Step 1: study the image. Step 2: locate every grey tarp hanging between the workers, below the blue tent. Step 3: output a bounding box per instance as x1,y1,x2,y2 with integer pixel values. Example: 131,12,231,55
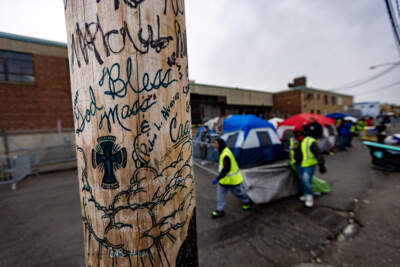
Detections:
241,162,299,204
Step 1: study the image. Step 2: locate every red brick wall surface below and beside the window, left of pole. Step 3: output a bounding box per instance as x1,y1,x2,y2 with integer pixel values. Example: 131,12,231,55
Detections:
0,55,74,131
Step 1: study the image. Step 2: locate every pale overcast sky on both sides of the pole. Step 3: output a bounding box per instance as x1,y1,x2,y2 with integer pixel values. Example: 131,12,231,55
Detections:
0,0,400,104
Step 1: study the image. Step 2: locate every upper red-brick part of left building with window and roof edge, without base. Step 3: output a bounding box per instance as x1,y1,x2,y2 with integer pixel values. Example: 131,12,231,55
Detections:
0,33,73,131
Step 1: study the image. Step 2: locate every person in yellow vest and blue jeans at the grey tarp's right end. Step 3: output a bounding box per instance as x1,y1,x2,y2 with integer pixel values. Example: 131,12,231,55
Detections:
294,129,326,208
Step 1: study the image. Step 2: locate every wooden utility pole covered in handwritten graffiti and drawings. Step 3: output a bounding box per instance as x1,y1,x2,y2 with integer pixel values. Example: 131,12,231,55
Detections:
64,0,197,267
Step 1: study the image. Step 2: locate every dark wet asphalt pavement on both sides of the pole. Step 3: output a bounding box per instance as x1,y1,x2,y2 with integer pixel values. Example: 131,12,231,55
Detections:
0,137,400,267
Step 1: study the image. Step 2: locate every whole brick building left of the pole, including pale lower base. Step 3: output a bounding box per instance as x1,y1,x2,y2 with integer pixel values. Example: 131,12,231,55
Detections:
0,32,76,164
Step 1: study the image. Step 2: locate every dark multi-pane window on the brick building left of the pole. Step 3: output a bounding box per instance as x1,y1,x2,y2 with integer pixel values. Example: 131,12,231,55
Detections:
0,50,35,83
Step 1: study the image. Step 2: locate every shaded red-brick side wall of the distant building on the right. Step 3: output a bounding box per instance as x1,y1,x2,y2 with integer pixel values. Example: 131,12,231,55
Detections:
271,90,301,117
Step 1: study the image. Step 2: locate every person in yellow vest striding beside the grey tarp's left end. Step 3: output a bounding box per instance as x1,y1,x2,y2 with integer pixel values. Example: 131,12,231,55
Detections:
211,138,250,218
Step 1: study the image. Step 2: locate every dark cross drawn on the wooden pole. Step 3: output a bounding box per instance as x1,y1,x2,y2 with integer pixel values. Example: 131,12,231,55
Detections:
92,135,126,189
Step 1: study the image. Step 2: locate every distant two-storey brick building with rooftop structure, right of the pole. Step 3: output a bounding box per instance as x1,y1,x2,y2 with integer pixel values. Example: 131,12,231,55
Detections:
271,77,353,117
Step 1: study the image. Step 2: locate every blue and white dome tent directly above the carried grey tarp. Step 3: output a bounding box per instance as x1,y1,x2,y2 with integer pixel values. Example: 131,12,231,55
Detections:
221,115,287,167
